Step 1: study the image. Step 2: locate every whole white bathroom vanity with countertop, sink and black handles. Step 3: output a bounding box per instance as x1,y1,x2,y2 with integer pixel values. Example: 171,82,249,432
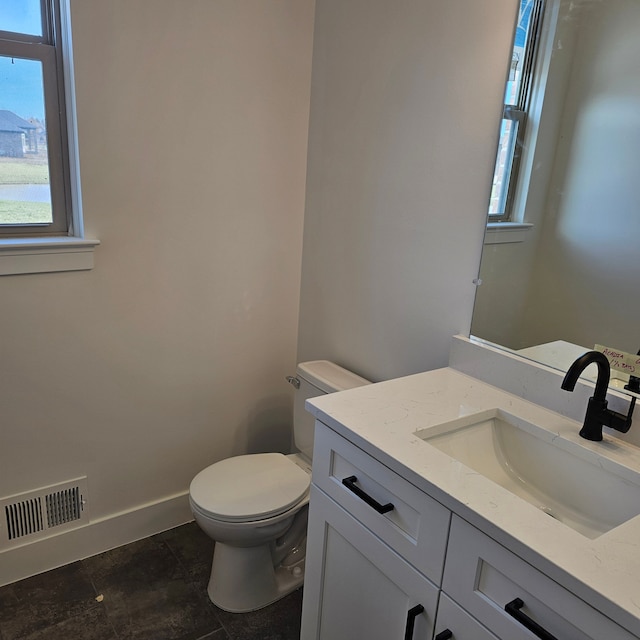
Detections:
301,338,640,640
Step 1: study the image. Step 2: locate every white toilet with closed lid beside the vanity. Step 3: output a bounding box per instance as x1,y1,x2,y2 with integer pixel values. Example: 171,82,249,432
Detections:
189,360,369,613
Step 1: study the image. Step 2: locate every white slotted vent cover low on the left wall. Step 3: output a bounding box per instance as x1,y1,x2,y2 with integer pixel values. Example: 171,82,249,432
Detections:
0,477,89,551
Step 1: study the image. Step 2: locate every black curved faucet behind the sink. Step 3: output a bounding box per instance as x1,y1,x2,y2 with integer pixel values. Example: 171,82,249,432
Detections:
562,351,636,441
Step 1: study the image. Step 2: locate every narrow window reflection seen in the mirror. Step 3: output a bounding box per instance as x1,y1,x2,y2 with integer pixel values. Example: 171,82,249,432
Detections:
489,0,544,222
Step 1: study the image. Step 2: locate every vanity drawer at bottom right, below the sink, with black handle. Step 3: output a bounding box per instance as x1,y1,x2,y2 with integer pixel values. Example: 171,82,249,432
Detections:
442,516,637,640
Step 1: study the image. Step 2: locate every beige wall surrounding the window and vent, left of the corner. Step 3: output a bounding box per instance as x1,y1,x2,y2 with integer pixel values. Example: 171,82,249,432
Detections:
0,0,314,581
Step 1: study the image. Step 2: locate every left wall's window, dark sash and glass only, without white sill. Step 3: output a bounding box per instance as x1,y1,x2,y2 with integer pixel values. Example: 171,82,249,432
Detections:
0,0,73,237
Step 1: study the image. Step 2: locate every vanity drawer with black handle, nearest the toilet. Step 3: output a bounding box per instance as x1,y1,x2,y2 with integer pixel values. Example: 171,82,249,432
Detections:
313,422,451,585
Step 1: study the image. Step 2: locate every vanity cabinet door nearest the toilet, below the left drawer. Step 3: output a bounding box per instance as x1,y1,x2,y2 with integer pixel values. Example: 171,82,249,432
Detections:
301,485,438,640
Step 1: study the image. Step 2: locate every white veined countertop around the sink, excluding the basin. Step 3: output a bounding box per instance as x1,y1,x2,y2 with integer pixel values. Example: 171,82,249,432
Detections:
307,368,640,637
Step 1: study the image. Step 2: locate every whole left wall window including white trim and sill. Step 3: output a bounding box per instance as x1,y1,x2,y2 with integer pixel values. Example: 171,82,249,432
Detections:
0,0,99,276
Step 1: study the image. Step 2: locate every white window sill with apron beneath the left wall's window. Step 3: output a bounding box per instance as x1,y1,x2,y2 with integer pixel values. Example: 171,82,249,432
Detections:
0,236,100,276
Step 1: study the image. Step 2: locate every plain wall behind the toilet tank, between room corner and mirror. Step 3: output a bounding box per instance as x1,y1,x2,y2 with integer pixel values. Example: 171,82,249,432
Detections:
298,0,518,380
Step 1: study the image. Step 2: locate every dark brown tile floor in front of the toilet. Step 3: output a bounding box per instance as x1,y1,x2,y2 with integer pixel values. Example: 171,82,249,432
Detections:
0,522,302,640
